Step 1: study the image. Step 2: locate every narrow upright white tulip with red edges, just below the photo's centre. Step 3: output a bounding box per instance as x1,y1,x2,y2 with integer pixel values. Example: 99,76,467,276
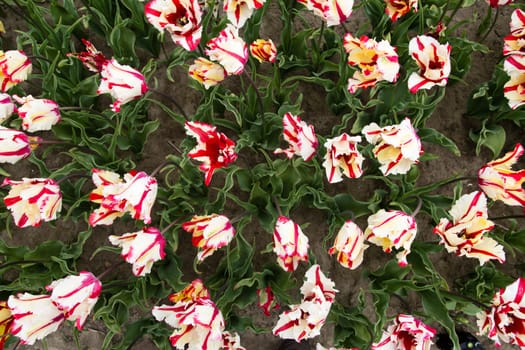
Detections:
273,215,308,272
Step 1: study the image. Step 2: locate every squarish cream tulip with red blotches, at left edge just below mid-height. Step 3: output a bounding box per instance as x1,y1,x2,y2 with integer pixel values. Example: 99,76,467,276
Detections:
2,178,62,227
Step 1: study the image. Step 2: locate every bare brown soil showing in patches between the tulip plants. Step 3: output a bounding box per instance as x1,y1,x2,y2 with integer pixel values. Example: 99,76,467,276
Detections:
2,0,525,350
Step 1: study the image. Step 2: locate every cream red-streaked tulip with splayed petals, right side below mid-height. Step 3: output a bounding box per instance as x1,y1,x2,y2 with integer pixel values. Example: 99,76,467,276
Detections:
434,191,505,265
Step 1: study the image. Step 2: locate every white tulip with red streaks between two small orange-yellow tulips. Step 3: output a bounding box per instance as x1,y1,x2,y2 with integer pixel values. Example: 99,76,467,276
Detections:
205,25,248,75
